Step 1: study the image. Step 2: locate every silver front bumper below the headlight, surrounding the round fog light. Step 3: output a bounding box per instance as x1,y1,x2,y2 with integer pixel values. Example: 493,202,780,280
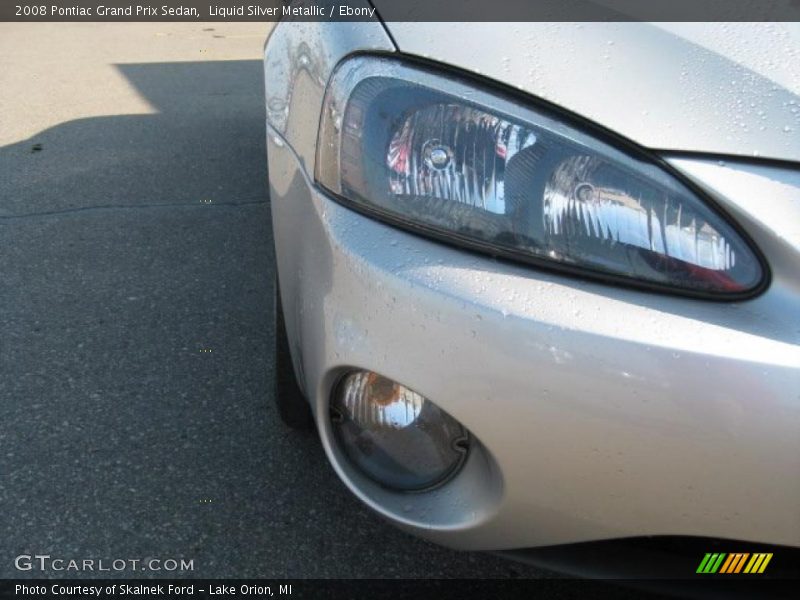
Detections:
268,126,800,550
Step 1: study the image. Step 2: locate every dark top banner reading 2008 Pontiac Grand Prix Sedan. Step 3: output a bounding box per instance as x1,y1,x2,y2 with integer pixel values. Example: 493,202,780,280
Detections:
0,0,800,22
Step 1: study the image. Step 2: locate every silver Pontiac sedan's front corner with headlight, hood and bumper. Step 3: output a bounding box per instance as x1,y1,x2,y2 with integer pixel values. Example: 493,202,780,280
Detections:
264,11,800,572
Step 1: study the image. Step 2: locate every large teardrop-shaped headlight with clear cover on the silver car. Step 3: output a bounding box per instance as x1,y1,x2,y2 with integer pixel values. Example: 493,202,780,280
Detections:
317,57,764,297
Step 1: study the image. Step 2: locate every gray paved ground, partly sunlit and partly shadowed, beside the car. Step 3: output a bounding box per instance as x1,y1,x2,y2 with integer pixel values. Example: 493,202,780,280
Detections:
0,24,556,577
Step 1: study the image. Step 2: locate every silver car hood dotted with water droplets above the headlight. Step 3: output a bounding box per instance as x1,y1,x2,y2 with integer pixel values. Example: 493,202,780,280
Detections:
386,22,800,161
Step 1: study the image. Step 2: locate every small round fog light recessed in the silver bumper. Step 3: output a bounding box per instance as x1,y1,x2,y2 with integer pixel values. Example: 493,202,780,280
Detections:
331,371,469,491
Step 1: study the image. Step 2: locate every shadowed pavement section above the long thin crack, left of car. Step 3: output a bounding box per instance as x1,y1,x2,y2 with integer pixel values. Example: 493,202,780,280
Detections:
0,61,267,215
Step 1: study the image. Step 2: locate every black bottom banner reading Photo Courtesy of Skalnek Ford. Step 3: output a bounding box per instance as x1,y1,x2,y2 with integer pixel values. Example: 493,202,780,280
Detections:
0,576,797,600
